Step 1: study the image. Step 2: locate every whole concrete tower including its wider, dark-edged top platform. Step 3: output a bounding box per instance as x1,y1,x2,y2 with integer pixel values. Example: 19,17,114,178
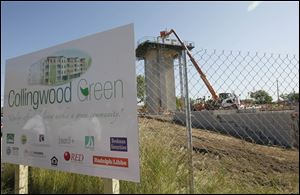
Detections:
136,38,194,114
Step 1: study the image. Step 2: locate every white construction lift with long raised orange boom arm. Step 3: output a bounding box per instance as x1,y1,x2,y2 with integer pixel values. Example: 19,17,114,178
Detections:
160,29,240,111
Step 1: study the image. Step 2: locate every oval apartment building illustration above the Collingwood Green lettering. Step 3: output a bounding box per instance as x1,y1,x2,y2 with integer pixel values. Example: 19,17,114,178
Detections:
28,51,91,85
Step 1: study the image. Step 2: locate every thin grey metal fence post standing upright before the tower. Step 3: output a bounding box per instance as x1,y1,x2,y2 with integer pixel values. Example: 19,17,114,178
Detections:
183,50,194,194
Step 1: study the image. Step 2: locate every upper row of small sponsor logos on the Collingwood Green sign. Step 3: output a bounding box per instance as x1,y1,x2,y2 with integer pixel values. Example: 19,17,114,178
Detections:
6,133,128,152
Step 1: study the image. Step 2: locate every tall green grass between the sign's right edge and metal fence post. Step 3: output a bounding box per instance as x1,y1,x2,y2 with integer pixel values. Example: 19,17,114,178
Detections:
120,129,187,194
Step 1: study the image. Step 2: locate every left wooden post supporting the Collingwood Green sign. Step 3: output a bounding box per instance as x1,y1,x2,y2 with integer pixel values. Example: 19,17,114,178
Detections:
15,165,28,194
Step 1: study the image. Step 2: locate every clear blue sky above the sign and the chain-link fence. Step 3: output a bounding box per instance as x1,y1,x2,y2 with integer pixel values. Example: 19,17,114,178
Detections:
1,1,299,105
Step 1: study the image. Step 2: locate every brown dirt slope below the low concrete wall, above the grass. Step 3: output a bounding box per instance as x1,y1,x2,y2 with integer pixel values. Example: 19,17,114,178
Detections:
139,118,299,187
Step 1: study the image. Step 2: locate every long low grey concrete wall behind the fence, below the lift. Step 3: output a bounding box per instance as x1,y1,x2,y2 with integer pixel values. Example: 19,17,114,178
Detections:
174,110,299,148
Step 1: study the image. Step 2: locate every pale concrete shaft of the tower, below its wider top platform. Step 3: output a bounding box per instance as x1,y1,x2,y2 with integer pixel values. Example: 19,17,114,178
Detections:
144,48,177,114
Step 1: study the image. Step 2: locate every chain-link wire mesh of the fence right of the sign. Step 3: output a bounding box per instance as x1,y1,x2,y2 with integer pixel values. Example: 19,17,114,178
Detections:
136,45,299,193
